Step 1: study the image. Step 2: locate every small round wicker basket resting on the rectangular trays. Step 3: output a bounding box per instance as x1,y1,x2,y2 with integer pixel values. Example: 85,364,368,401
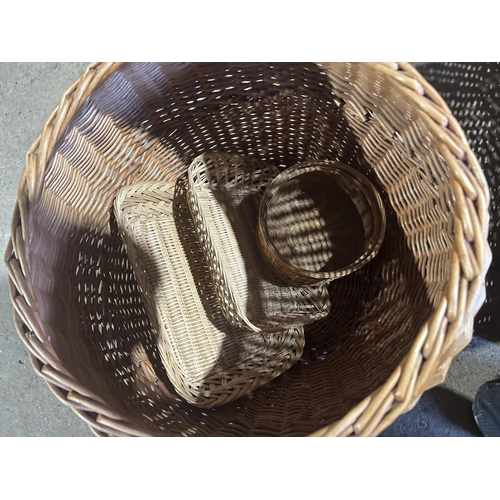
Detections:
257,161,385,286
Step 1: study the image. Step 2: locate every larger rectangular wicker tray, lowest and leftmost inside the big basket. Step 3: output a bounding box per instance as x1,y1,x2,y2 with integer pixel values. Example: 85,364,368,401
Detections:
115,176,304,406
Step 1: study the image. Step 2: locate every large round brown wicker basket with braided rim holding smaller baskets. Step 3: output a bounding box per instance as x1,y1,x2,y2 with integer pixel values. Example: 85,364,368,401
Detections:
6,63,490,436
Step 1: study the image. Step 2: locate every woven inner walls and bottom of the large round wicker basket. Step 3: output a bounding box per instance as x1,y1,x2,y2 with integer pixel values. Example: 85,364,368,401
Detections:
27,63,453,436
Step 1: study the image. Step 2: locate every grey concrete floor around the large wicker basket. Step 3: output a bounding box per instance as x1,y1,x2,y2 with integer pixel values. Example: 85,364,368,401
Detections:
0,63,500,436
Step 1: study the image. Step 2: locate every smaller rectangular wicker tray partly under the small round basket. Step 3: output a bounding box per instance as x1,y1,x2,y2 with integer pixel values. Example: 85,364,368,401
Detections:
187,152,330,332
